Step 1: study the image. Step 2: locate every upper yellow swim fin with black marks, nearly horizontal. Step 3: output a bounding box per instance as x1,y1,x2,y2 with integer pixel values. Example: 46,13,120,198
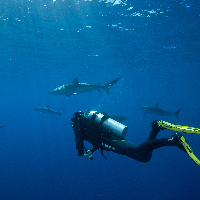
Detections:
157,120,200,134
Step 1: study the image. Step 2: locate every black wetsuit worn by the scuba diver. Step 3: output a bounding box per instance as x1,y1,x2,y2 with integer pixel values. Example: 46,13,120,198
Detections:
72,117,175,162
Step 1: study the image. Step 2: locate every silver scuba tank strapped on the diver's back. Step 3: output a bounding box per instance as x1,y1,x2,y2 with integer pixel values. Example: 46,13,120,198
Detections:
84,111,128,138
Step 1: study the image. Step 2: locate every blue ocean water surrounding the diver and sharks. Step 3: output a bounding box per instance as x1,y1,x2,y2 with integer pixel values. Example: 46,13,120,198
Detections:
0,0,200,200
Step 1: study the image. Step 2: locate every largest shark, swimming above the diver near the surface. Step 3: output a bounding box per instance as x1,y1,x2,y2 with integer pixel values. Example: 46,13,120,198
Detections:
49,77,121,97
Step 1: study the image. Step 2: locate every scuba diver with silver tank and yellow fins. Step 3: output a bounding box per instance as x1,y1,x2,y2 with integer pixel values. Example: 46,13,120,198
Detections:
71,111,200,165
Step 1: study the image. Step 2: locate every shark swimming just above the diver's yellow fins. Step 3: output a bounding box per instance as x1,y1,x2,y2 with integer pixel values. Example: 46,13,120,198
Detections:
141,103,181,119
